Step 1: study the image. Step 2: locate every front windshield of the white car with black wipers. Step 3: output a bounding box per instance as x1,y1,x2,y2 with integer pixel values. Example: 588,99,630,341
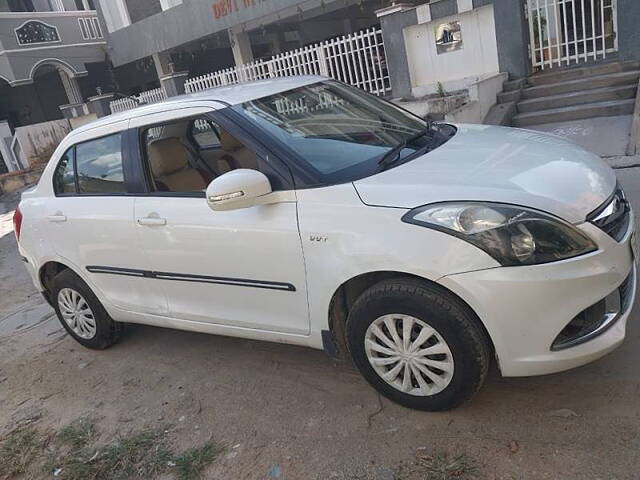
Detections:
231,81,455,184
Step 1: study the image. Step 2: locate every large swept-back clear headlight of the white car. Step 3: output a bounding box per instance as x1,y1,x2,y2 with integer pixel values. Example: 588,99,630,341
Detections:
402,202,597,266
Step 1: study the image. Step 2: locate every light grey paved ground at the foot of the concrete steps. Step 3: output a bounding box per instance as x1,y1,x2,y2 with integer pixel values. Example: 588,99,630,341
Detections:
530,115,632,157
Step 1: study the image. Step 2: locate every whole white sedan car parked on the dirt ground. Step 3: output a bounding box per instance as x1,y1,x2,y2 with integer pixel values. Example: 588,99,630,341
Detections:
15,77,636,410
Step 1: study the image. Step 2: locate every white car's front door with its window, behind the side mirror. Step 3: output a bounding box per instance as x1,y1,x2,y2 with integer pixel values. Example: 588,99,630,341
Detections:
134,111,309,334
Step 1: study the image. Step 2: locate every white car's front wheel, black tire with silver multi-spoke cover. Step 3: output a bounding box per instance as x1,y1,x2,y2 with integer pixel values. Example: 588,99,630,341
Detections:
347,279,491,411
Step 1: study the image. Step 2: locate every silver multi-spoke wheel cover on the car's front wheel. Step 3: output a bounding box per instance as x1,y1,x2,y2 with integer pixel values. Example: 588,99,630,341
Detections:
364,314,454,397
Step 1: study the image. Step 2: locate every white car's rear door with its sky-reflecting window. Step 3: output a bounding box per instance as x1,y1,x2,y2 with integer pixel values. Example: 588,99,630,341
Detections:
45,122,167,314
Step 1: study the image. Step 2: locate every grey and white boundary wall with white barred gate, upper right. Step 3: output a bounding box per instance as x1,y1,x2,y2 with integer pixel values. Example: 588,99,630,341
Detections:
379,0,640,97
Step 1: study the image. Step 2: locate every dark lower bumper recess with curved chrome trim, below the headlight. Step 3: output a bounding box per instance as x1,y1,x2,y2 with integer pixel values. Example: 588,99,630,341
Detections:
551,269,635,351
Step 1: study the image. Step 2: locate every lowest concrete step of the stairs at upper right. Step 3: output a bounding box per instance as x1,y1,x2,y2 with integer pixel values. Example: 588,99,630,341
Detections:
513,99,636,127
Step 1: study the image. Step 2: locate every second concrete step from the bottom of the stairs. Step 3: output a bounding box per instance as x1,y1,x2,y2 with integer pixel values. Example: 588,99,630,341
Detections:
518,83,638,113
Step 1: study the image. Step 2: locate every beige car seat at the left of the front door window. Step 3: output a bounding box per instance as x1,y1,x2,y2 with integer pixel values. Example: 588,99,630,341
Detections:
149,138,207,192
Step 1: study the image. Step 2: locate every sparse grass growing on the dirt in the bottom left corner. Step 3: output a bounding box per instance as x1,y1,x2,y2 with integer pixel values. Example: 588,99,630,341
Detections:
0,417,223,480
